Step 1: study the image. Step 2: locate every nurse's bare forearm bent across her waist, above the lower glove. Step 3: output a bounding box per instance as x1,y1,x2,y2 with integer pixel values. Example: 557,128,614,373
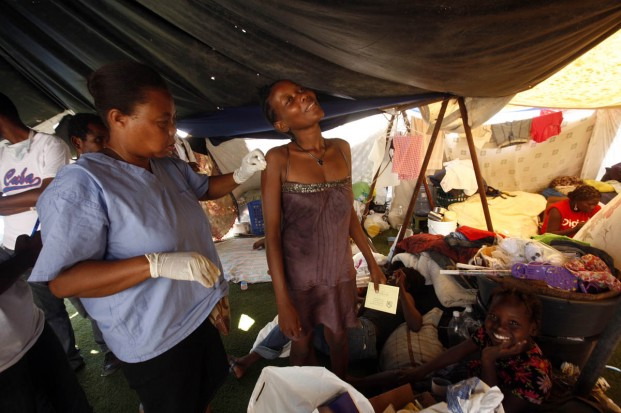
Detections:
49,255,151,298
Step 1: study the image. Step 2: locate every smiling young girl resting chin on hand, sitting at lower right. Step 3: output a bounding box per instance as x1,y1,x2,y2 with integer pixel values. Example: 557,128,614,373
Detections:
406,288,552,412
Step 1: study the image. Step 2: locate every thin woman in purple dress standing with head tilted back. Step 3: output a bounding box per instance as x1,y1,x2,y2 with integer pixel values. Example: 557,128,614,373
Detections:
261,80,386,378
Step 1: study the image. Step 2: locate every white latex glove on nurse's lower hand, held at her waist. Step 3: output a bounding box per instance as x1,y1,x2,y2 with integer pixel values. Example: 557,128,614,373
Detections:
145,252,220,288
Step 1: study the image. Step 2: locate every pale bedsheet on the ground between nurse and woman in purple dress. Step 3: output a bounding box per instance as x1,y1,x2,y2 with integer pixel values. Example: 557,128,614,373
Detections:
216,237,272,283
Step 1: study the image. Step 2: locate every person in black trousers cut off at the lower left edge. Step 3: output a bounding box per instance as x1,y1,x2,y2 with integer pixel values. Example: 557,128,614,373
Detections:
0,232,93,413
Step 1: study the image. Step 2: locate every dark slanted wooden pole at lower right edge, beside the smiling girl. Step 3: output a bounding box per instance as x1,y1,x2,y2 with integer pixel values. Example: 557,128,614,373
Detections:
574,299,621,397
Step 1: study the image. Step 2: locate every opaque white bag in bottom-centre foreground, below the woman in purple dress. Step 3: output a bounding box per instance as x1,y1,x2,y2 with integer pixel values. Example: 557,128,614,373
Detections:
248,366,373,413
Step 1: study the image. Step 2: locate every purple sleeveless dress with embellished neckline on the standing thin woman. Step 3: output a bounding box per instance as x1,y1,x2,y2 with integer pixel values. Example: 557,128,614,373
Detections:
282,177,358,332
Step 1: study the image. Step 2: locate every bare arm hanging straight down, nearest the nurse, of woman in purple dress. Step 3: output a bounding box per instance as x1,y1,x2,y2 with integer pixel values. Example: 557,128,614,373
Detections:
261,148,301,340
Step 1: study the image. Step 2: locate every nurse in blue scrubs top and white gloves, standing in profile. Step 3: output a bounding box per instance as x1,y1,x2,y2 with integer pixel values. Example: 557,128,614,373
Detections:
30,62,265,413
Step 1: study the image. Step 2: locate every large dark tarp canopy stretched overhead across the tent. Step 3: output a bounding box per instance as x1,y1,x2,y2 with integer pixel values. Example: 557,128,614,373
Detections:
0,0,621,129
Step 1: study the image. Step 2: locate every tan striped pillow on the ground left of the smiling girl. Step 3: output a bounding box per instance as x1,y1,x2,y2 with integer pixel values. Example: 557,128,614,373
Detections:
379,308,444,371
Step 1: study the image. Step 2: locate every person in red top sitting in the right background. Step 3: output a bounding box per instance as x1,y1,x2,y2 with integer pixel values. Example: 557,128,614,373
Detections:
541,185,602,237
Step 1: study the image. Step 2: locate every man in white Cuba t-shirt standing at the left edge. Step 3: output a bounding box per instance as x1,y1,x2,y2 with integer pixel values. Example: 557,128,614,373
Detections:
0,93,84,369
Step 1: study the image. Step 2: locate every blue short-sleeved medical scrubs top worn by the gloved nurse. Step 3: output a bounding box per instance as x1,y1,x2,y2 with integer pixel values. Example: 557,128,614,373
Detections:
29,153,228,362
